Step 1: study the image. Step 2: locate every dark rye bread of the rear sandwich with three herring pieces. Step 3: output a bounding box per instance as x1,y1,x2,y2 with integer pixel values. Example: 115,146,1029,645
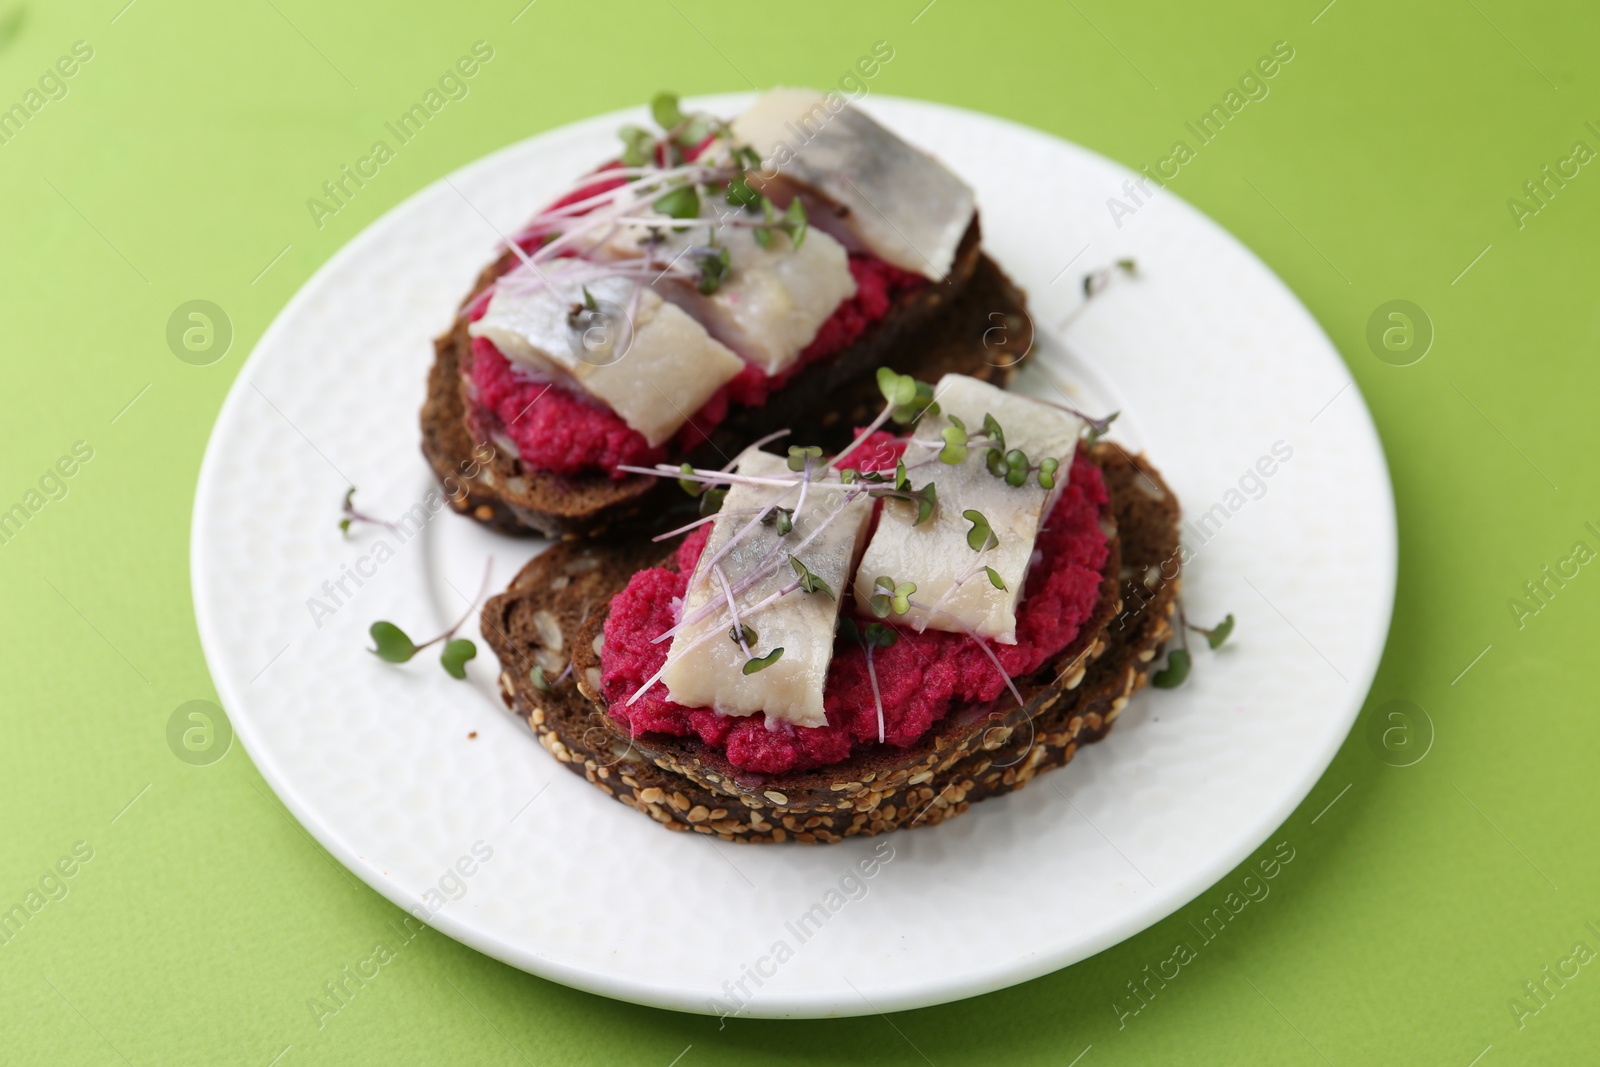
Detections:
422,219,1034,537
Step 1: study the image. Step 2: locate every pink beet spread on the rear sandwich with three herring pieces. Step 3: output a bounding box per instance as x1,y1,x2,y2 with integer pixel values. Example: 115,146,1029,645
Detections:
469,155,928,480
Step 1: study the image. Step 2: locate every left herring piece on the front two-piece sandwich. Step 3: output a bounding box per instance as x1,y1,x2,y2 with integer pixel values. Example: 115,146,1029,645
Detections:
662,450,872,726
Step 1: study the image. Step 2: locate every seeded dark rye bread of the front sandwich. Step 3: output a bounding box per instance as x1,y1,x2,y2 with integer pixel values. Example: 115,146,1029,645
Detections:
482,443,1179,843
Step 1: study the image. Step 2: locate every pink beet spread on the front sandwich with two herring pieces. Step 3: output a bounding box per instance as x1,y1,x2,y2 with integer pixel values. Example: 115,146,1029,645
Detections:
600,434,1109,774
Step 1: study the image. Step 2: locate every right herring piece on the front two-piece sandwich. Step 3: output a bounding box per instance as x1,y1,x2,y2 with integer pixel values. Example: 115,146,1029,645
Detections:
854,374,1083,645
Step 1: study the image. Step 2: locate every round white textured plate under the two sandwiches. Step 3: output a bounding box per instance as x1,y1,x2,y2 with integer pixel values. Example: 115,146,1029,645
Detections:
192,96,1395,1017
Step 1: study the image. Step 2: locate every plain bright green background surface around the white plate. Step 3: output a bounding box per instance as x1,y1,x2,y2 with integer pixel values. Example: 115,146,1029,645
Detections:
0,0,1600,1067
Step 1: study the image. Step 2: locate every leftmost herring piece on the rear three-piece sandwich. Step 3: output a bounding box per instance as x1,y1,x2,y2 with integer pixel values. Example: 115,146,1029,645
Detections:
467,259,744,446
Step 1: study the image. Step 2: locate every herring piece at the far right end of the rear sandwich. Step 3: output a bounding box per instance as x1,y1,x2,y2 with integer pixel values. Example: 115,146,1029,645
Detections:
733,88,976,282
